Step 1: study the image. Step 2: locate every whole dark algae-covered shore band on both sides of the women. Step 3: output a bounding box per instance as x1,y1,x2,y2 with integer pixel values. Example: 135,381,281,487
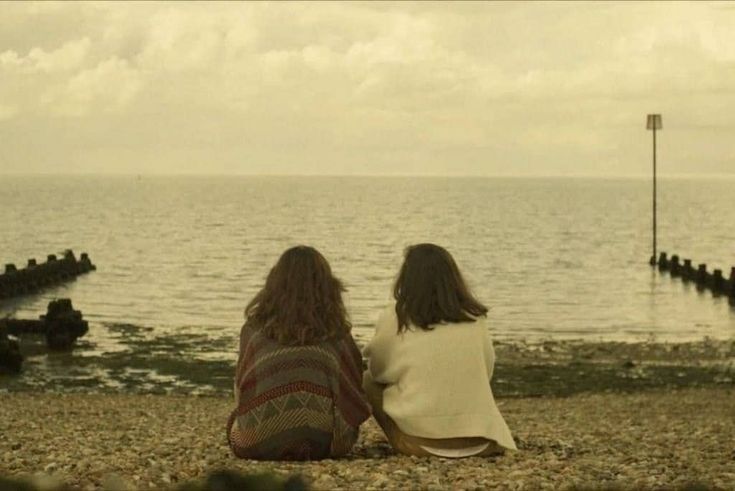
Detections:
0,324,735,398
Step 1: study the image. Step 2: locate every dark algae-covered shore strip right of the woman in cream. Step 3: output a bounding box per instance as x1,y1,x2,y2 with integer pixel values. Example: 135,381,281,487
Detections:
492,339,735,397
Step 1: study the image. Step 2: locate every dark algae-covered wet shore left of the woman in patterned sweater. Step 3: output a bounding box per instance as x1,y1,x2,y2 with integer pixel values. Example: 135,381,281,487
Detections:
0,324,235,394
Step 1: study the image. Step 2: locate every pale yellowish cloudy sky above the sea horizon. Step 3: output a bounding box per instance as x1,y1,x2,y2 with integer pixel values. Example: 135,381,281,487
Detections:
0,2,735,177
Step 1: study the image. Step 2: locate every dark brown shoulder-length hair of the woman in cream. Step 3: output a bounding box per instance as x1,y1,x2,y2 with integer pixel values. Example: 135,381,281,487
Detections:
393,244,487,333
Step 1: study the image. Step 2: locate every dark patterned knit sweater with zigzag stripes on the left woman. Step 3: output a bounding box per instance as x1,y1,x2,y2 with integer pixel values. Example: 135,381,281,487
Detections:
227,326,370,460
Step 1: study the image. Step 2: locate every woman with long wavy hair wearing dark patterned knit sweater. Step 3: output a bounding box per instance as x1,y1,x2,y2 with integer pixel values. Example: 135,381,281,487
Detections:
227,246,370,460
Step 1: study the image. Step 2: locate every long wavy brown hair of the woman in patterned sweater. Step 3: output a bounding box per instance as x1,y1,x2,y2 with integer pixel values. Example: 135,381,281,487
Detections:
245,245,352,345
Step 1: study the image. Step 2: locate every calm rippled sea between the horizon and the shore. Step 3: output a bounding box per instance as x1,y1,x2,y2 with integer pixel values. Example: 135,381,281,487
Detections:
0,177,735,357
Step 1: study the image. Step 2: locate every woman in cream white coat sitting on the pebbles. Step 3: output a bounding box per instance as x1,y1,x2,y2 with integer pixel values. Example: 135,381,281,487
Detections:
363,244,516,457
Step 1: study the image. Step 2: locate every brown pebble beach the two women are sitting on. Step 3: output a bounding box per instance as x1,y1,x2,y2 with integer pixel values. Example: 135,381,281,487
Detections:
0,390,735,490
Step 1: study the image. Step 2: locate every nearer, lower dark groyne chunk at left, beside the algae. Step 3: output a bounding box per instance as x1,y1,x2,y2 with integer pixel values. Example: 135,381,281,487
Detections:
0,298,89,373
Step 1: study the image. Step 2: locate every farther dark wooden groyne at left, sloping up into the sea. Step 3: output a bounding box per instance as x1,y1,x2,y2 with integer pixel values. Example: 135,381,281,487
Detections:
0,249,97,299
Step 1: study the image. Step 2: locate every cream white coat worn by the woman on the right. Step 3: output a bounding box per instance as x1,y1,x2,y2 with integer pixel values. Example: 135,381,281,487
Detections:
364,305,516,450
